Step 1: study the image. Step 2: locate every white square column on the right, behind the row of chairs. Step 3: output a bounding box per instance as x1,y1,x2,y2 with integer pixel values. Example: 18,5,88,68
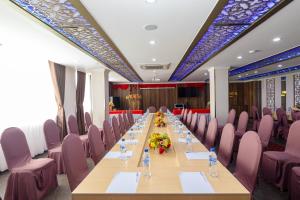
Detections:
208,67,229,124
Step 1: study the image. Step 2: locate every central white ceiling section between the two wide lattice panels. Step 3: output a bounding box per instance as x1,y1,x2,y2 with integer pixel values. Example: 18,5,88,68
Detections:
81,0,217,82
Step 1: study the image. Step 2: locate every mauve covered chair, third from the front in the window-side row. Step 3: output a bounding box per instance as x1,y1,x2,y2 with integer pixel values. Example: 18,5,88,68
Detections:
68,115,90,157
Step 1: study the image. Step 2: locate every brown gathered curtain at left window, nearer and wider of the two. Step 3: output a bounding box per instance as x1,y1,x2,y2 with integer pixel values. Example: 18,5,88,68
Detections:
49,61,67,140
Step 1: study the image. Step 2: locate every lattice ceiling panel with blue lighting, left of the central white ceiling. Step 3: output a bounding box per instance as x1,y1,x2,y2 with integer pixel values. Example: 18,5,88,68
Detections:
11,0,142,82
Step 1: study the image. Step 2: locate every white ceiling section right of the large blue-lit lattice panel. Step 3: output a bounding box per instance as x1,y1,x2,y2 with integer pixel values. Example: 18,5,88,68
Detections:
184,0,300,81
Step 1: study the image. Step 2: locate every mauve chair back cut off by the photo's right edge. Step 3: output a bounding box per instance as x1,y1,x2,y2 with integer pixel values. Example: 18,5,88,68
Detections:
285,120,300,157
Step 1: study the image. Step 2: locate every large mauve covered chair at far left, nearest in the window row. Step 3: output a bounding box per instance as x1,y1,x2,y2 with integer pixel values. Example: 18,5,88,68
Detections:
1,128,58,200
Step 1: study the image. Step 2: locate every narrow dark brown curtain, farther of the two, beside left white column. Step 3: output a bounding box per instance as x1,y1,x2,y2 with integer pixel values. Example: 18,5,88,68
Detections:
76,71,85,135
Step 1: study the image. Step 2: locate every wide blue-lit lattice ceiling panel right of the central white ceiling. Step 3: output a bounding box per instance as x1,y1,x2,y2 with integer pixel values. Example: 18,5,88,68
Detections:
169,0,283,81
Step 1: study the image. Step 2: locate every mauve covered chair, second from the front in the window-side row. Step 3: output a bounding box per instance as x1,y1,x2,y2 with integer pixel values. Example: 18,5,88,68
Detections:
44,119,65,174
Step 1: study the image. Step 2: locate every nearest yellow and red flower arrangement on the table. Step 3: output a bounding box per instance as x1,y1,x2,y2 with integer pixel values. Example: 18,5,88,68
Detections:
148,133,171,154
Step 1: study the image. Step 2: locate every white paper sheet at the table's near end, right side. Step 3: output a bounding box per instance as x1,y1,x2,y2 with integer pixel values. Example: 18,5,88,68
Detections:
179,172,214,194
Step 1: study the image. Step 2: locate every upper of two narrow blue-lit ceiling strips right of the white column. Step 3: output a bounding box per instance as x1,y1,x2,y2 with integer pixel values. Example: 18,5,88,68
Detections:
229,46,300,76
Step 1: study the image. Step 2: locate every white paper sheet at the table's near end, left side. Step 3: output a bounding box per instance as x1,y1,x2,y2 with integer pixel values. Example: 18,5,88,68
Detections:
106,172,141,194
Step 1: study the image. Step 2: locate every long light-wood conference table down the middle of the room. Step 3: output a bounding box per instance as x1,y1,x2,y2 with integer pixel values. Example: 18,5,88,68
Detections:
72,114,250,200
